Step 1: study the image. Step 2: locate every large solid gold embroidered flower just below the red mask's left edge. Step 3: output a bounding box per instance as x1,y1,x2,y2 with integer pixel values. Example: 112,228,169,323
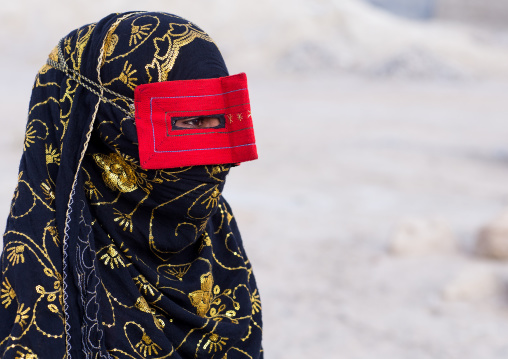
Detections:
93,153,138,193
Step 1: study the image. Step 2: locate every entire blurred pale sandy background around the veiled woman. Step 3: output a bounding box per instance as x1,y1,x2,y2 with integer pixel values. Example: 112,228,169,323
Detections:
0,0,508,359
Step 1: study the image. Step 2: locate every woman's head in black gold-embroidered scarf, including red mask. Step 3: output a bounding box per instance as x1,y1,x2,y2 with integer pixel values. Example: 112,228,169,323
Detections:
46,12,257,168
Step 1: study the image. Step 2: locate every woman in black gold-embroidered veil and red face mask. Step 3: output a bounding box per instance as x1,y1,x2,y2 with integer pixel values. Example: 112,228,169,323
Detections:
0,12,263,359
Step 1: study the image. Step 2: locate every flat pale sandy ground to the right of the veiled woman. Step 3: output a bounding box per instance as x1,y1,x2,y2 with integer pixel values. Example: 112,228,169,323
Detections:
226,74,508,359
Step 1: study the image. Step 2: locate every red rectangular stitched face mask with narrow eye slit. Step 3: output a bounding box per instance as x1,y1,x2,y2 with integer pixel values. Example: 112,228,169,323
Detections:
134,73,258,169
